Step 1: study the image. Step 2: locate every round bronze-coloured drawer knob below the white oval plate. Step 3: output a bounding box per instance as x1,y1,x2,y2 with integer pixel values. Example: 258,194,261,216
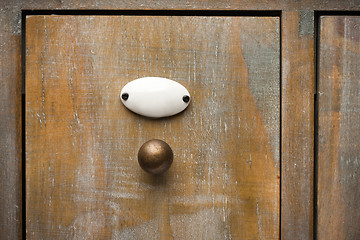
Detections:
138,139,174,175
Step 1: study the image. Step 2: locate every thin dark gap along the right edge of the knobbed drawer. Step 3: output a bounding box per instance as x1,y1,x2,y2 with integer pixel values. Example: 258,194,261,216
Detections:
279,11,283,239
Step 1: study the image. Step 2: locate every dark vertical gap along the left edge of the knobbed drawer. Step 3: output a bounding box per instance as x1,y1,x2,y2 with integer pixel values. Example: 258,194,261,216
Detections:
21,11,26,239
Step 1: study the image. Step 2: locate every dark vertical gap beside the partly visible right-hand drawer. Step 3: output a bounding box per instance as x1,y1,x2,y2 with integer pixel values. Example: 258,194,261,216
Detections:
313,12,321,240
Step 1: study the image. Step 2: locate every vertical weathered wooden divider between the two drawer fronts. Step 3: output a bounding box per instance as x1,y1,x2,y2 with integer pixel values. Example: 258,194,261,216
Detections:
281,11,315,239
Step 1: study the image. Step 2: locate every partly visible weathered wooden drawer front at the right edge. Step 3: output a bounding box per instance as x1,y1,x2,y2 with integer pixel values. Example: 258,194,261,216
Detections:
317,16,360,239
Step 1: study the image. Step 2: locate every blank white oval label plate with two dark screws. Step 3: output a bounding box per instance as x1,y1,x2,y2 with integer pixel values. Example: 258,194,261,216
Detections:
120,77,190,118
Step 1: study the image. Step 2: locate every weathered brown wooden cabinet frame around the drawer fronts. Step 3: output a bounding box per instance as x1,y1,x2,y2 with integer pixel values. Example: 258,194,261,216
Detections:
0,0,360,240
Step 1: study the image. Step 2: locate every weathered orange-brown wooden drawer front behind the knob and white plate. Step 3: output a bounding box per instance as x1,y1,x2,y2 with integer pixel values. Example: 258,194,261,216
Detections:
26,16,280,239
